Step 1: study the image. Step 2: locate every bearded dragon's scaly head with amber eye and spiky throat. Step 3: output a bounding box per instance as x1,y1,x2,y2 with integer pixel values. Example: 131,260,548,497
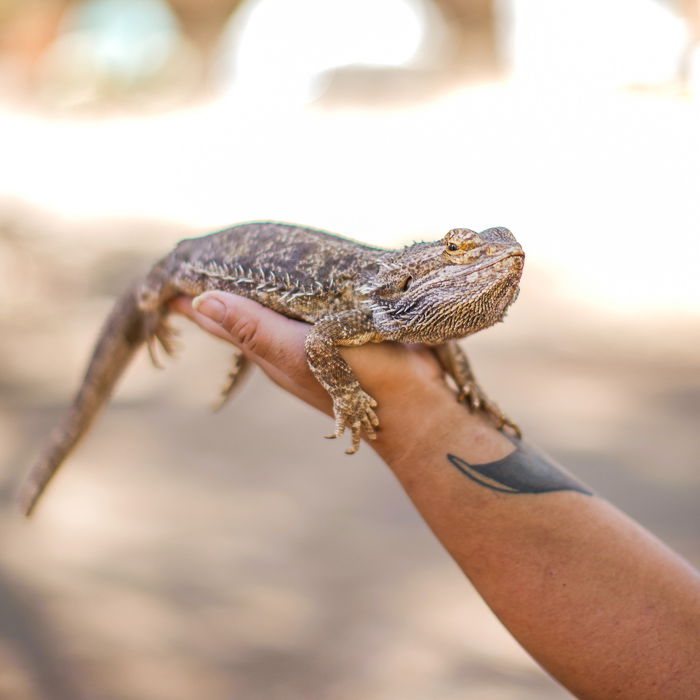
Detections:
361,227,524,344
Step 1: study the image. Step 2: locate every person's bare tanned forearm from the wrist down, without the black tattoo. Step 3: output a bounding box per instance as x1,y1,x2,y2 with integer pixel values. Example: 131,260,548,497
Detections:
368,370,700,699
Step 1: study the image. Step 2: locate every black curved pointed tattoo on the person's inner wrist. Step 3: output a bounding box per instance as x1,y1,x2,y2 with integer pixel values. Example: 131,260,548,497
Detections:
447,439,593,496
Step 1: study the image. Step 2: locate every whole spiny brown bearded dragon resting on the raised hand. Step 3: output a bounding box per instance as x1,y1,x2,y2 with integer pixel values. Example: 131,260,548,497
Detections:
20,222,524,515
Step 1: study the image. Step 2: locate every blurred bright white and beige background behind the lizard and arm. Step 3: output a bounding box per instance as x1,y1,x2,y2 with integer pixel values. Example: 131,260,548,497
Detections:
0,0,700,700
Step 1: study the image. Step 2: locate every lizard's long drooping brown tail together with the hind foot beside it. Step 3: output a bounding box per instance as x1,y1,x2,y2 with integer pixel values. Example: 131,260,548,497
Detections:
18,288,171,516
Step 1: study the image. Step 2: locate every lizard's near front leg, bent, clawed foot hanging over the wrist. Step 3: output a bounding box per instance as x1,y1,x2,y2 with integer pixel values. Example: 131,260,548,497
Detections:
304,309,380,454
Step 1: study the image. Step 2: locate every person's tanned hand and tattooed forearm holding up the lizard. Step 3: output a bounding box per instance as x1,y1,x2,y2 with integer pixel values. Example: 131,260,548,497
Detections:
174,292,700,700
